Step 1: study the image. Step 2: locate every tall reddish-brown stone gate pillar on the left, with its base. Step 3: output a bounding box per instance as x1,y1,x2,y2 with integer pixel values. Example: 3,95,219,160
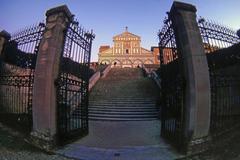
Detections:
31,5,72,150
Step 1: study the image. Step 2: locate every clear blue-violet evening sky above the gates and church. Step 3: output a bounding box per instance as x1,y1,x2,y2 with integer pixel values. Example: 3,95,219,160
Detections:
0,0,240,61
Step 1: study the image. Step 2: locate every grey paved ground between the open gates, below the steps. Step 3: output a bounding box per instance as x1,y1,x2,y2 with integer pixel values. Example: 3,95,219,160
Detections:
57,120,182,160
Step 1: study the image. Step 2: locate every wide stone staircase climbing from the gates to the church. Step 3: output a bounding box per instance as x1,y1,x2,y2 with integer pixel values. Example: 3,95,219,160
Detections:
89,68,159,121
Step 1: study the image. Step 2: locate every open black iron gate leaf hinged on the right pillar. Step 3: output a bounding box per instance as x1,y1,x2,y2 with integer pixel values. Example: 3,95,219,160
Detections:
158,18,185,147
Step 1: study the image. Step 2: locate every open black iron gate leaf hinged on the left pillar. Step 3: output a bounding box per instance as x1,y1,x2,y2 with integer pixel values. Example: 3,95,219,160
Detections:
57,21,94,143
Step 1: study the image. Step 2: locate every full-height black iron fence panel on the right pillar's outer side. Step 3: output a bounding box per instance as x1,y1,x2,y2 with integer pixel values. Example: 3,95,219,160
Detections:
198,18,240,136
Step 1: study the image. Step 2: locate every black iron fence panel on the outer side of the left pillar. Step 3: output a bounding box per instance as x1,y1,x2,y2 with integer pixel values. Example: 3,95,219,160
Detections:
0,23,45,133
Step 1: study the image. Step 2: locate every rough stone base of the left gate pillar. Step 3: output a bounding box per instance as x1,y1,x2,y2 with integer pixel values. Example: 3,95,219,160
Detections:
29,132,57,152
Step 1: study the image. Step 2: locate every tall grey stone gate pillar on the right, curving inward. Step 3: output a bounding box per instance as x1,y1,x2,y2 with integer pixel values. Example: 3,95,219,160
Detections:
170,2,211,153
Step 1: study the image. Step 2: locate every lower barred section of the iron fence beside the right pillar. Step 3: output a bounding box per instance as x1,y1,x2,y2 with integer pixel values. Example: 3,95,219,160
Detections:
210,74,240,135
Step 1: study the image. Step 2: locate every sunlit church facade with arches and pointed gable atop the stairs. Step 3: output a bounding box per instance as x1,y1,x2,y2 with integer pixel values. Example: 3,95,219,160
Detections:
98,27,159,68
